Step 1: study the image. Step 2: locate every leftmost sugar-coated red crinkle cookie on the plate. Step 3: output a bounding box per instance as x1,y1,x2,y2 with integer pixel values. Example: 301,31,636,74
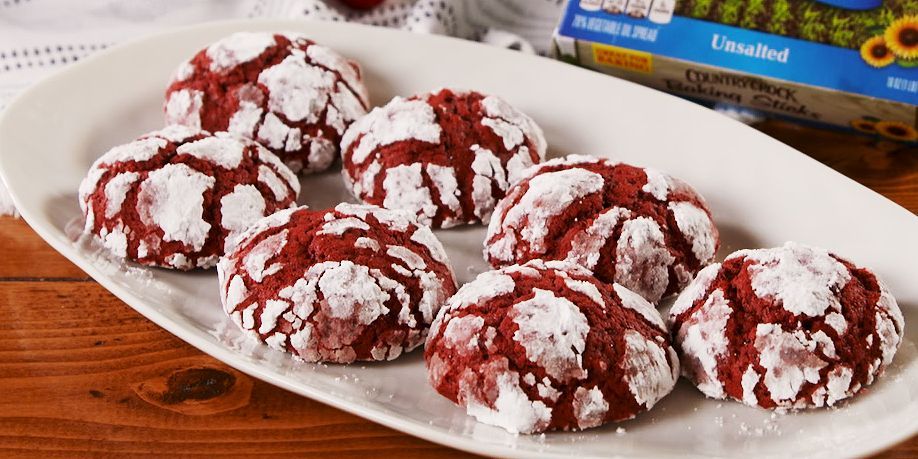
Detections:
79,125,300,270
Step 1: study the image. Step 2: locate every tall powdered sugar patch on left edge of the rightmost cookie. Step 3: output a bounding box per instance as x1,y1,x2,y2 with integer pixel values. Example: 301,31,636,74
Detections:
676,289,733,398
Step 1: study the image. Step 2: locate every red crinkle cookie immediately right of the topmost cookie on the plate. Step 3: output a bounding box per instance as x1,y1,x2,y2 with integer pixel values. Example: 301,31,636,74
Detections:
341,89,546,228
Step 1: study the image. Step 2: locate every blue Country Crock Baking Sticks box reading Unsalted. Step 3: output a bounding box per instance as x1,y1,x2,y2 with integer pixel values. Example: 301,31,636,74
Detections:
552,0,918,142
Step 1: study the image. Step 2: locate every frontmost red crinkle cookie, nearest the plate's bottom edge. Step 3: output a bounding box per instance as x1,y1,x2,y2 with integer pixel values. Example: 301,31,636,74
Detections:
424,260,679,433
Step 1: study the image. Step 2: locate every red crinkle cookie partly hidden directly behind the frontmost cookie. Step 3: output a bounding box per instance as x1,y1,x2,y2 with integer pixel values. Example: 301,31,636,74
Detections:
484,155,719,303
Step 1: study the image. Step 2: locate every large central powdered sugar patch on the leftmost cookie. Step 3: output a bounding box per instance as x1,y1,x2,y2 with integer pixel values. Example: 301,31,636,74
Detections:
137,164,215,251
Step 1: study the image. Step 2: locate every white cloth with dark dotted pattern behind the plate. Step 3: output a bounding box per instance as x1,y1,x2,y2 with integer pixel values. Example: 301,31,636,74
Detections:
0,0,565,214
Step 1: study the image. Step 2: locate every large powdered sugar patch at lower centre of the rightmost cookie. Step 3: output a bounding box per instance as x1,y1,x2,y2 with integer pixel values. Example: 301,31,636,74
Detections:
755,324,826,407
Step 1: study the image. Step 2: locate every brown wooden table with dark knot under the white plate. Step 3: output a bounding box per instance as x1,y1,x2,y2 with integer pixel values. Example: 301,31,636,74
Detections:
0,122,918,458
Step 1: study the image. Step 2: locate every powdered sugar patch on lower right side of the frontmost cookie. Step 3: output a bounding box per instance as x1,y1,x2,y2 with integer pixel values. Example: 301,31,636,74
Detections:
622,330,676,409
